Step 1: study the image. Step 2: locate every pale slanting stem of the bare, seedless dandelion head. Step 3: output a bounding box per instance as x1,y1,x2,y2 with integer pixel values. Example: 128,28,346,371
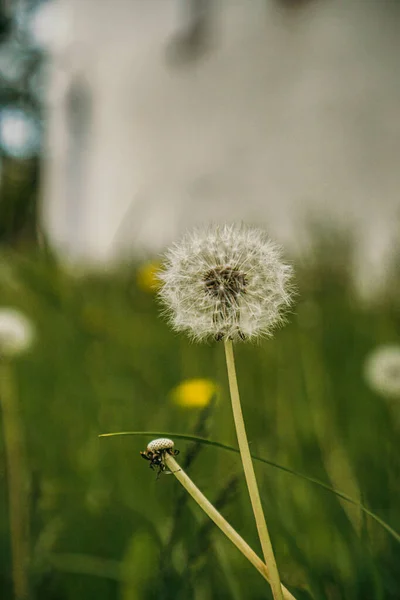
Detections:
164,453,296,600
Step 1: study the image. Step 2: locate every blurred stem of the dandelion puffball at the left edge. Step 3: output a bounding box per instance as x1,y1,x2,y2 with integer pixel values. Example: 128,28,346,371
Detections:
0,358,29,600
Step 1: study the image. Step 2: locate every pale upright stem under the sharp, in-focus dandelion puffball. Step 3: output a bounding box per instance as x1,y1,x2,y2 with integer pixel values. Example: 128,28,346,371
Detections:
225,340,283,600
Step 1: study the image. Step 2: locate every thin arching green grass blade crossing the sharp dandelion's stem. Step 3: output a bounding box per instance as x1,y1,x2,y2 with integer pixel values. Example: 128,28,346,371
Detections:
99,431,400,543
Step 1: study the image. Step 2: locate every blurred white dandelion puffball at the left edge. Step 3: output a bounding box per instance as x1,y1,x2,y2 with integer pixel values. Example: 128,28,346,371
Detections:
0,308,34,357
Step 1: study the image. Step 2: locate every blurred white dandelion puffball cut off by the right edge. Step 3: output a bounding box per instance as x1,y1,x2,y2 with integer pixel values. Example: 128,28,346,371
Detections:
364,345,400,399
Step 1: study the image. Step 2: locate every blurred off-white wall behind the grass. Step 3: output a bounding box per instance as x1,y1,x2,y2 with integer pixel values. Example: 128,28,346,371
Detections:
42,0,400,290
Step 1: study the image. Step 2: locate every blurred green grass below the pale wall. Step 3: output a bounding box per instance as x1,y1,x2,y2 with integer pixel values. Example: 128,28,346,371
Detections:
0,230,400,600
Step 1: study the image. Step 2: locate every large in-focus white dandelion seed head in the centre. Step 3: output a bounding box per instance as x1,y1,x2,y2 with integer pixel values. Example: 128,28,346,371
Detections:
159,225,293,341
